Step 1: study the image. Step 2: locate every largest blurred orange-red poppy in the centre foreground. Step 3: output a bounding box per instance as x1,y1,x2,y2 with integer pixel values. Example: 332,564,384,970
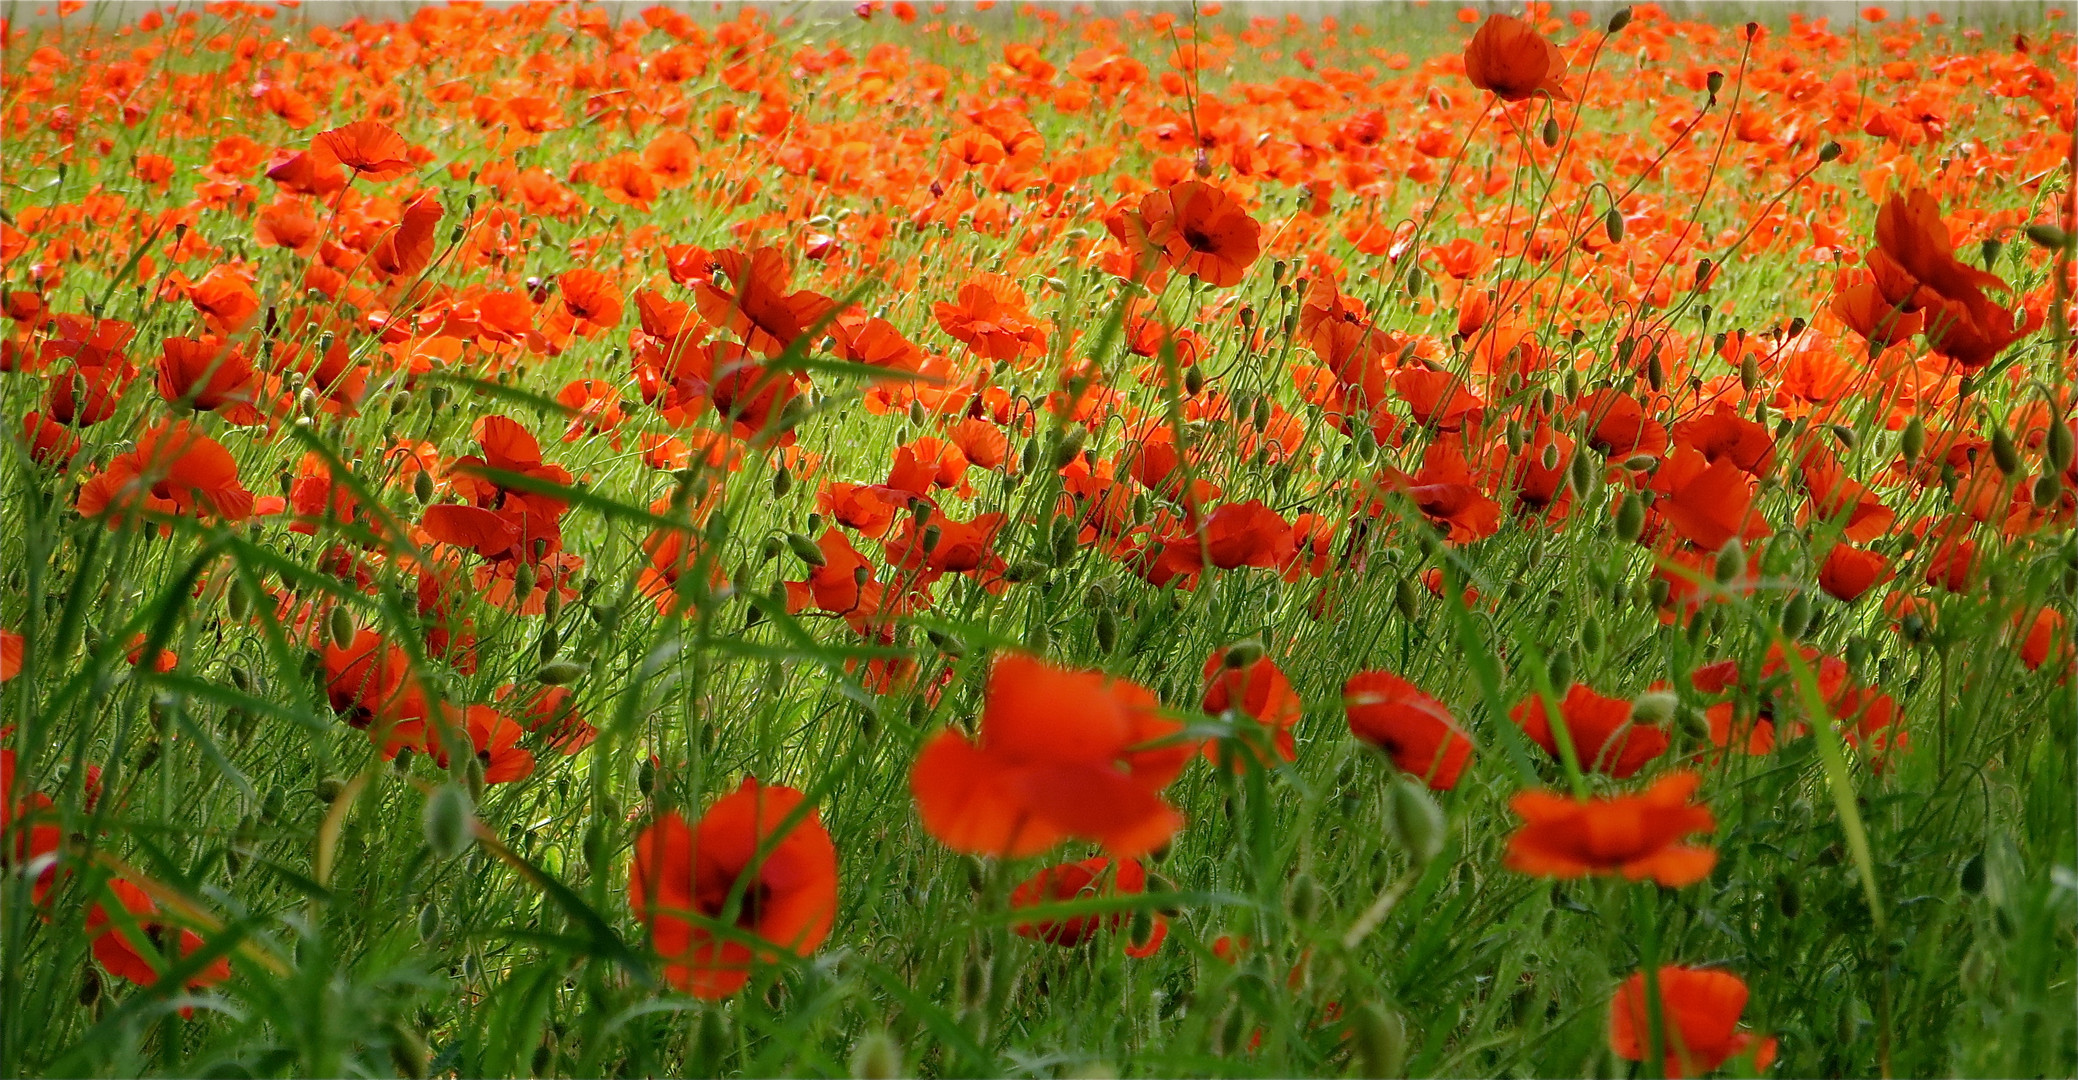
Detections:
910,654,1195,858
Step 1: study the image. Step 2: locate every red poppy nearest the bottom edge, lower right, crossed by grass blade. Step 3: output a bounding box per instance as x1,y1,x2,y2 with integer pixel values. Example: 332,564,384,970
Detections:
1608,964,1775,1076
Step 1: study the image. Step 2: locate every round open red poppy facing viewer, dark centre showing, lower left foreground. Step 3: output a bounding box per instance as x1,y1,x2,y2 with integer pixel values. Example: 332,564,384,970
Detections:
628,777,837,999
